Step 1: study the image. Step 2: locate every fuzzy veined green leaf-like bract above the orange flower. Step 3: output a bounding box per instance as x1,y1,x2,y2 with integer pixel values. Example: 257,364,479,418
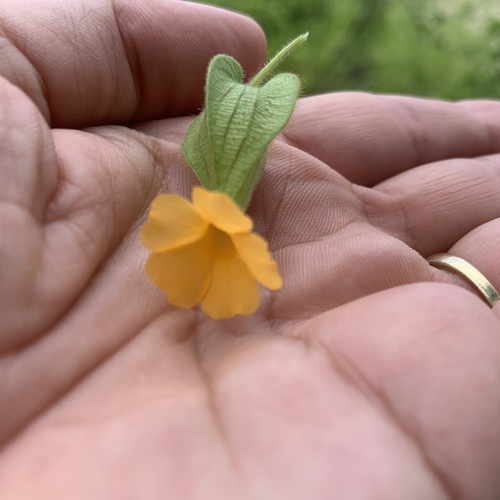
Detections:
183,33,306,208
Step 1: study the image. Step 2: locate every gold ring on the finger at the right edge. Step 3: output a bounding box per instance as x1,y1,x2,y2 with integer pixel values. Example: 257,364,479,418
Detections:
427,253,500,307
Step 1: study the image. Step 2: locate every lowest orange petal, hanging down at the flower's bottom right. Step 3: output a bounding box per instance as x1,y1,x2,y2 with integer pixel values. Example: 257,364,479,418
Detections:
201,252,260,319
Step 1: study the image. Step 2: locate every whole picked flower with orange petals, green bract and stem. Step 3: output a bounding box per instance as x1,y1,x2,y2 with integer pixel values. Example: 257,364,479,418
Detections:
141,35,307,319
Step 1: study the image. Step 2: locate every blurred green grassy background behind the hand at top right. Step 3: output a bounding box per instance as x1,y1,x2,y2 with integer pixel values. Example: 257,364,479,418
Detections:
201,0,500,99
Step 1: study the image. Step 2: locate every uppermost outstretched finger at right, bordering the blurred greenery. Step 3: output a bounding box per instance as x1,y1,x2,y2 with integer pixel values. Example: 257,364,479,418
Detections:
285,93,500,186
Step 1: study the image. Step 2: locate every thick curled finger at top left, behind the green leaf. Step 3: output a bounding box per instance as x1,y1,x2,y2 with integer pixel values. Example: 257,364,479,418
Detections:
0,0,265,127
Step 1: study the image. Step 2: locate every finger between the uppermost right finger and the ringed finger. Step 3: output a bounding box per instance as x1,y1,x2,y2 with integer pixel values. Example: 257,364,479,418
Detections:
358,155,500,257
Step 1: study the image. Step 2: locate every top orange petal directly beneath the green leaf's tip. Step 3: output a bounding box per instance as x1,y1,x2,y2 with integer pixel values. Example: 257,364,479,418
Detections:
193,186,253,234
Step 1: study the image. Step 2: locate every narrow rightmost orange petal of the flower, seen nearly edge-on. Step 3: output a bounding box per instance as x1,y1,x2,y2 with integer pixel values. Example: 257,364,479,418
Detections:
231,233,283,290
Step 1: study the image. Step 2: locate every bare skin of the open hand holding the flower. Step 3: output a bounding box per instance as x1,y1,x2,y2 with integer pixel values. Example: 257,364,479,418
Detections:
0,0,500,500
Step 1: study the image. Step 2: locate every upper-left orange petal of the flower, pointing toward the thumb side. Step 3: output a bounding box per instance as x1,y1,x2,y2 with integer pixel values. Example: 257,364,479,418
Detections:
141,194,208,252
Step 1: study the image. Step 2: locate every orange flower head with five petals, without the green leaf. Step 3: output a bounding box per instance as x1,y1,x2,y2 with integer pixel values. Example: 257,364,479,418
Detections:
141,187,281,319
